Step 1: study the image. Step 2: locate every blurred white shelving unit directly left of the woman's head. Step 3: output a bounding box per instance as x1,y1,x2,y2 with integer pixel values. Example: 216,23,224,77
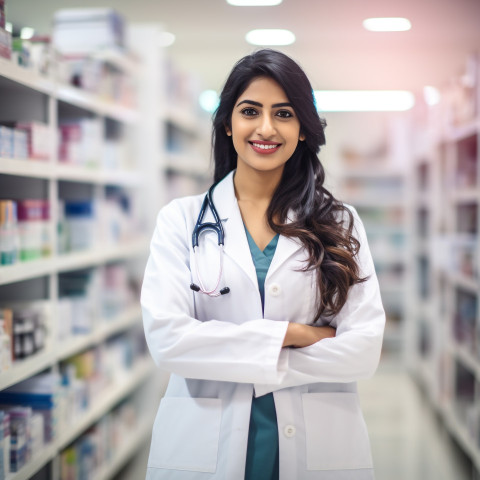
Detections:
129,24,212,221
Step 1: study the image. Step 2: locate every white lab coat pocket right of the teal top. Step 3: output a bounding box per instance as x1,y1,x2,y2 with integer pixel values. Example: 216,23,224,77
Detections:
302,392,373,470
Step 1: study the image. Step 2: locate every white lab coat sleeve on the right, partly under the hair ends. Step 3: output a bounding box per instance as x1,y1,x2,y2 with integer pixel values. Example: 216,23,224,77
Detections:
255,207,385,396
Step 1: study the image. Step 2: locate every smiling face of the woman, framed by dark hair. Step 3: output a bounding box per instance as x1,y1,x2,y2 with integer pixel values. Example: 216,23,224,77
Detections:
226,77,304,176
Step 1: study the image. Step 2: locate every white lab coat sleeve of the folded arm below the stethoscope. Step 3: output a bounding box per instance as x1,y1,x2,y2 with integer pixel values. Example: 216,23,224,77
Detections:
141,201,288,383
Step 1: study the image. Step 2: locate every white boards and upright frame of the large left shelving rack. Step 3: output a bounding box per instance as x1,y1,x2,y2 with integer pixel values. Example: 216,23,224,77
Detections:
0,31,155,480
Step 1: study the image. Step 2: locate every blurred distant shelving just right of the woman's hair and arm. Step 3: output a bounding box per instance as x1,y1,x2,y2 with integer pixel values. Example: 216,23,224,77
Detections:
334,117,408,355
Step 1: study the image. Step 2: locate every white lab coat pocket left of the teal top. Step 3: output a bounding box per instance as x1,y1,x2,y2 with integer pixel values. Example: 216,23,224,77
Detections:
148,397,222,473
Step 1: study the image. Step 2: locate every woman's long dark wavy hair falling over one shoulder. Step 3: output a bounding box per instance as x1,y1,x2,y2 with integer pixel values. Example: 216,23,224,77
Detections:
212,49,365,322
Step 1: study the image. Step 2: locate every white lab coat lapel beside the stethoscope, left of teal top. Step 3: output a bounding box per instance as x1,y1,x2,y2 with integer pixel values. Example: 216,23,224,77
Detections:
213,172,258,287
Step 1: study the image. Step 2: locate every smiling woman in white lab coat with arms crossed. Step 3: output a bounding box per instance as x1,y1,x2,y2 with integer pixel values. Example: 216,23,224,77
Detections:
142,50,385,480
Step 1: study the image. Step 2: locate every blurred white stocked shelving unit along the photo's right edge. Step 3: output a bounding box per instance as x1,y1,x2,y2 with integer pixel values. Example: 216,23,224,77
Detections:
406,56,480,479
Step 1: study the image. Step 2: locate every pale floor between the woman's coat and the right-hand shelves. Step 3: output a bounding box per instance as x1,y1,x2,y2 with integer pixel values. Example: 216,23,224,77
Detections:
359,352,474,480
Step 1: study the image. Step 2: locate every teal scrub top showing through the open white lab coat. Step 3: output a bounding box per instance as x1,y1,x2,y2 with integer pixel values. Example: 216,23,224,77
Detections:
245,227,279,480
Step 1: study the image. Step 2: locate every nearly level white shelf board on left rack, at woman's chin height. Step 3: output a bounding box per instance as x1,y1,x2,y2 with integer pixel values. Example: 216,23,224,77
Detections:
0,157,143,187
